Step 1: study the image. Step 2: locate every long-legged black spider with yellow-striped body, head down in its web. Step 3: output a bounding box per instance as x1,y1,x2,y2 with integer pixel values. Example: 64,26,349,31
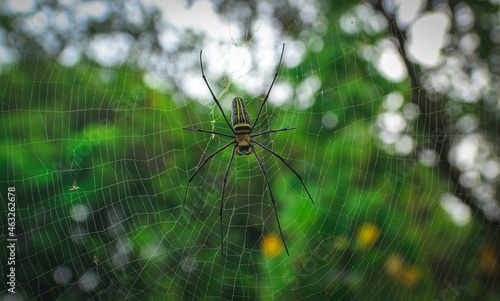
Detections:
182,43,314,256
